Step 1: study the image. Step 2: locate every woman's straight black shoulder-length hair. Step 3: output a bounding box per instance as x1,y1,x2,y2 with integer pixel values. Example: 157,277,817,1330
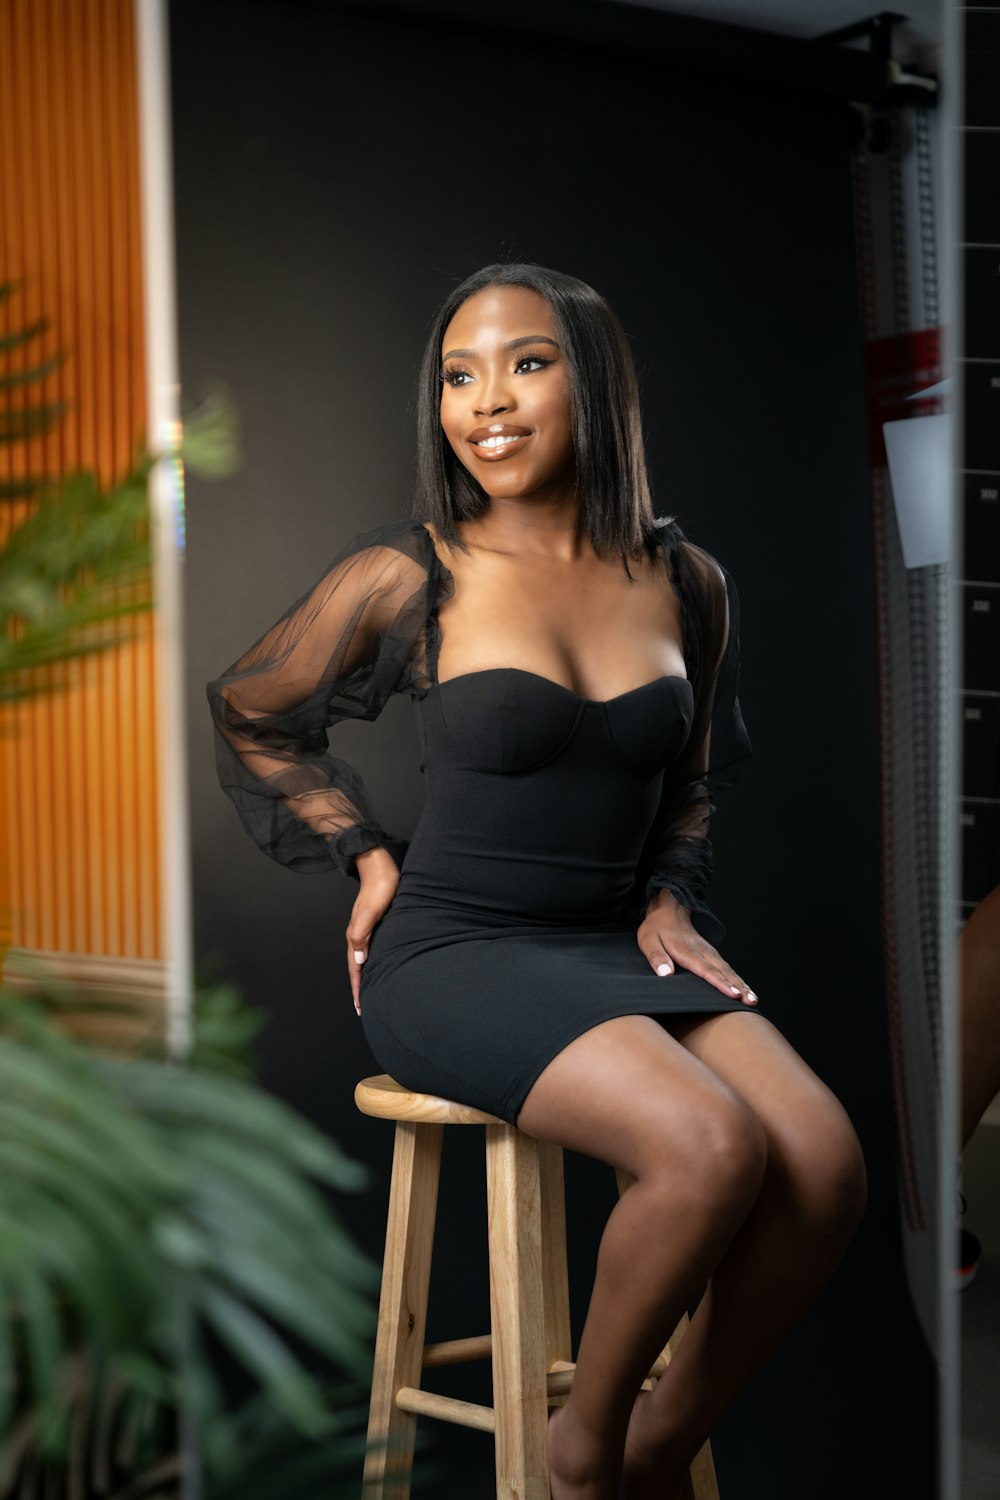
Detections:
414,261,666,578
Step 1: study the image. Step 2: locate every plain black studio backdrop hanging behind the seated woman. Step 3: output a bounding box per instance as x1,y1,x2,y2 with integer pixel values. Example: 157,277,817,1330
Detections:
171,0,936,1500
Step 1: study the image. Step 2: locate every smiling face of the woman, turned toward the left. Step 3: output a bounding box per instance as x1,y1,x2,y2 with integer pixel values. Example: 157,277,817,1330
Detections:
441,287,576,497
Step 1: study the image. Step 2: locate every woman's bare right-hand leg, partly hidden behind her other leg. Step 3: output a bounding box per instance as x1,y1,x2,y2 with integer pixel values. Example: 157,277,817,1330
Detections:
625,1011,865,1500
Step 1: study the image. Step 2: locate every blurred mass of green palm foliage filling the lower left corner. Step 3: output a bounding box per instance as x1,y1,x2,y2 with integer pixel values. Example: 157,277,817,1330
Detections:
0,977,429,1500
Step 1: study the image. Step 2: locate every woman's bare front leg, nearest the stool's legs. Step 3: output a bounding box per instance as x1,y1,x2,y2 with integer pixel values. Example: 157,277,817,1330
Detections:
517,1016,766,1500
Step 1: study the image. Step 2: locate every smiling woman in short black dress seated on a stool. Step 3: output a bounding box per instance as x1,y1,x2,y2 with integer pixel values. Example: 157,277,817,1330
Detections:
208,264,865,1500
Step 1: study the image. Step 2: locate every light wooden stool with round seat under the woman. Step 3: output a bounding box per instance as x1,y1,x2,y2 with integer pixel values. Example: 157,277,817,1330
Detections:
354,1073,718,1500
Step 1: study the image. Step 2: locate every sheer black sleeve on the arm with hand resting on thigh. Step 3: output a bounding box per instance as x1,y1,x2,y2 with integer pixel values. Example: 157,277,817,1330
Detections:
640,525,753,944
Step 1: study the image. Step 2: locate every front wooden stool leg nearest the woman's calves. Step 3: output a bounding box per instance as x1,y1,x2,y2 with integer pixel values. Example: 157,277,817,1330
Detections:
486,1124,550,1500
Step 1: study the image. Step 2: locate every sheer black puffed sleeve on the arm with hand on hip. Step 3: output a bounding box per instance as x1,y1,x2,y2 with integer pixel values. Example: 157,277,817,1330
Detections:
205,521,441,879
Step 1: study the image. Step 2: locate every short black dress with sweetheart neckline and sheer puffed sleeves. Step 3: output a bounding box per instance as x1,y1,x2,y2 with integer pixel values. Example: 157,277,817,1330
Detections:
207,519,759,1124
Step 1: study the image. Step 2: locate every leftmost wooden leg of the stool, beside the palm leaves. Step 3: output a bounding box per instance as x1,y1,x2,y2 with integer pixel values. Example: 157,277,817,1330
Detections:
363,1121,444,1500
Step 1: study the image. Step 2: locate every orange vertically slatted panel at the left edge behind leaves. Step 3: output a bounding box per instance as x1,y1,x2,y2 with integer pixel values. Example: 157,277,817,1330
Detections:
0,0,162,959
